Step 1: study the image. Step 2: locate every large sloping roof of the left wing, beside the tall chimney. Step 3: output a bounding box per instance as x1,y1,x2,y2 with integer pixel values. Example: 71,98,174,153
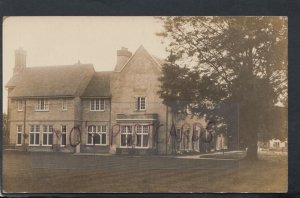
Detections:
6,64,95,97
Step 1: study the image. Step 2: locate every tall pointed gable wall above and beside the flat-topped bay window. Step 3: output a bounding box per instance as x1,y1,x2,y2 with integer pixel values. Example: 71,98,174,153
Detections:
111,49,171,153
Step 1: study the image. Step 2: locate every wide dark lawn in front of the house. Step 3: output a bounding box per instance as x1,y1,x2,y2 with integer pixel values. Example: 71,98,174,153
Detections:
3,151,287,193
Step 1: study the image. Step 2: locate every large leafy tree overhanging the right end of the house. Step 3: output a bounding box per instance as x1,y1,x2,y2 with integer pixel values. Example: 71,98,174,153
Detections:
157,17,287,159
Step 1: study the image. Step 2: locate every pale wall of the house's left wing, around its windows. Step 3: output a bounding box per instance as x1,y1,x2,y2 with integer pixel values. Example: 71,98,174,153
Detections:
9,98,81,151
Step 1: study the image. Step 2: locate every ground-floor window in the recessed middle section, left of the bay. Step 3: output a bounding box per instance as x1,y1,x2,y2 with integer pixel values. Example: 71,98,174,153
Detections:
87,125,106,145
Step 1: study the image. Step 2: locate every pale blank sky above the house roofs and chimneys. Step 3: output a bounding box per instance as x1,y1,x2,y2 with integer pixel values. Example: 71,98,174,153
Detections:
2,16,167,112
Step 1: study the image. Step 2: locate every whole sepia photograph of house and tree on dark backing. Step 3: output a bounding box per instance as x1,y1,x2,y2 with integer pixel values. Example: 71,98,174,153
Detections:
2,16,288,194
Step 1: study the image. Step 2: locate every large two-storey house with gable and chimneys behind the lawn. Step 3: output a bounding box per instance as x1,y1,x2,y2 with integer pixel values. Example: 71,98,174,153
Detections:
6,46,225,154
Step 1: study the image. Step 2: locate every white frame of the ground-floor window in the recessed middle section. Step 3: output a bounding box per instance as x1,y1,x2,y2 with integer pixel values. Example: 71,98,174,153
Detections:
87,125,107,146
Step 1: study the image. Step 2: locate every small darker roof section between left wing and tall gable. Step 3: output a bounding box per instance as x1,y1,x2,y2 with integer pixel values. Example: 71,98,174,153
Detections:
82,72,113,98
